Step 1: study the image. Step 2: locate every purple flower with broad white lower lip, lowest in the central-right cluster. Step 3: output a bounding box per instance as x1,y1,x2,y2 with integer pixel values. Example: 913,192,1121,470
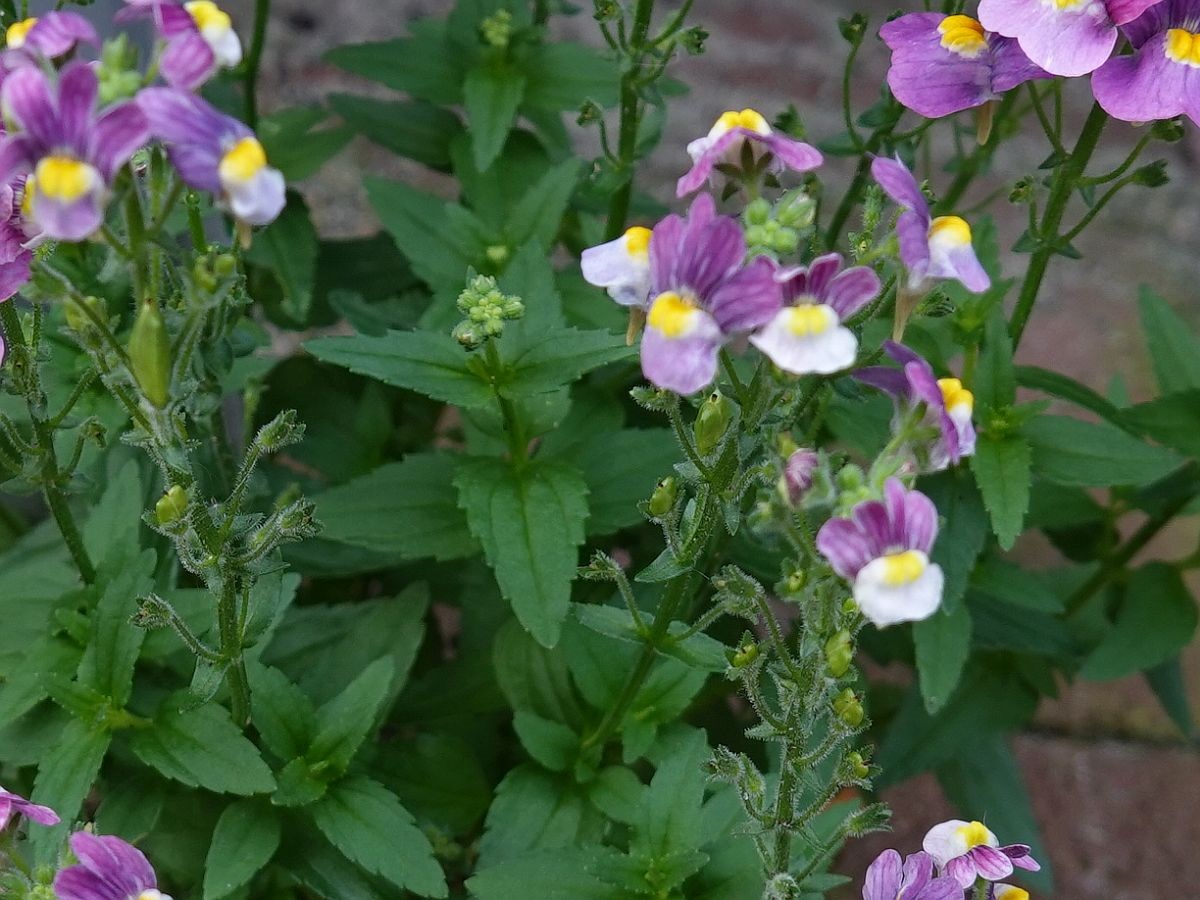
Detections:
817,478,944,628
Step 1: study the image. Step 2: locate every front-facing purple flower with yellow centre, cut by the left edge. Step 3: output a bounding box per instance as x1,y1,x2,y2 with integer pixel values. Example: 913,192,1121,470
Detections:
0,62,149,241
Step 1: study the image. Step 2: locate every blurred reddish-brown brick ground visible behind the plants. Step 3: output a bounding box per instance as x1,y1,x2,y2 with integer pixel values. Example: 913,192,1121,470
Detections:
166,0,1200,900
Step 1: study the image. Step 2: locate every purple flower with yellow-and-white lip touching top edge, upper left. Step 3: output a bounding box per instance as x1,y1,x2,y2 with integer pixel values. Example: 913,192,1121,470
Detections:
116,0,241,90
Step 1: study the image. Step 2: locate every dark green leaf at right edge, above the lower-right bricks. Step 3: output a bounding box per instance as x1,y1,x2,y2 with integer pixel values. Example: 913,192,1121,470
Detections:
1079,563,1198,680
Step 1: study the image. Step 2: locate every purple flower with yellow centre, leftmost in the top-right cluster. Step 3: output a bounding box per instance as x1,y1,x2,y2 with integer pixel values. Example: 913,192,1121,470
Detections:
880,12,1050,119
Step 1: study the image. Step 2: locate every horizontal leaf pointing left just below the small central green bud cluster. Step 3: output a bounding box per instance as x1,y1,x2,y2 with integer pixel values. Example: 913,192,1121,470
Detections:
305,331,494,408
